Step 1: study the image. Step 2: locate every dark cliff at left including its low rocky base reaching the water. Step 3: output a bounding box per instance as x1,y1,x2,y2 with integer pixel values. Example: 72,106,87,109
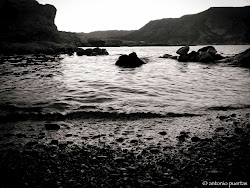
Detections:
0,0,84,55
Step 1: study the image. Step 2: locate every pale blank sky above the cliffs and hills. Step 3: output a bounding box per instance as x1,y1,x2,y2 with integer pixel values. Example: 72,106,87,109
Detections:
37,0,250,33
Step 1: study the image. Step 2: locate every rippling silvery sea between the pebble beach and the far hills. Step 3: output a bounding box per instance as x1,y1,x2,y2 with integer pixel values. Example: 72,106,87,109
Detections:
0,45,250,121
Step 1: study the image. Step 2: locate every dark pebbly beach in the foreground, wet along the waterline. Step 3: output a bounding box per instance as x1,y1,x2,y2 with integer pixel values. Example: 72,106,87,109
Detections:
0,108,250,187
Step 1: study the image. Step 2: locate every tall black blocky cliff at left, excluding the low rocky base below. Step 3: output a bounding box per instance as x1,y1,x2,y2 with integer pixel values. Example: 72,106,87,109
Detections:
0,0,59,43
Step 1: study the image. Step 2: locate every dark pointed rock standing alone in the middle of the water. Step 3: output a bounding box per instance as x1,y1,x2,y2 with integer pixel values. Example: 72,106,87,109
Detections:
115,52,145,68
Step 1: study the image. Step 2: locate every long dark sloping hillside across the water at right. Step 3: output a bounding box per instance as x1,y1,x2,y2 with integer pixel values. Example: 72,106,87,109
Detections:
119,6,250,45
